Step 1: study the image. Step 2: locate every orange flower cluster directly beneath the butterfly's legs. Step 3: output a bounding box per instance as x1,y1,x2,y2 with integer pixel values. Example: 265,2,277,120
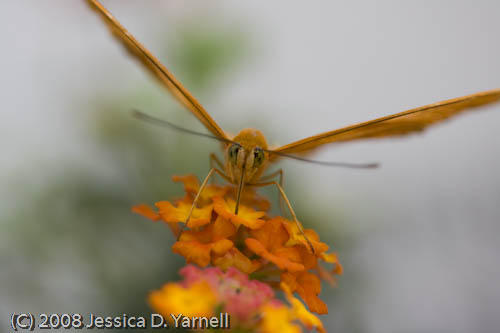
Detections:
133,175,342,328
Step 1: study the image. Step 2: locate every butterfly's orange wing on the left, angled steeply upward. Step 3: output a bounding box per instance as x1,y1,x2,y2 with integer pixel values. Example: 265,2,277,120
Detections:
87,0,228,139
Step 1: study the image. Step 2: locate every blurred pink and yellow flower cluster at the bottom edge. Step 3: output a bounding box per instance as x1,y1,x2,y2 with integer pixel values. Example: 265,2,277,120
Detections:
149,265,324,332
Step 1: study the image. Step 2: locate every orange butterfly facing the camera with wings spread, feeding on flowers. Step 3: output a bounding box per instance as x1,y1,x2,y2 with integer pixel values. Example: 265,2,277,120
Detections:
87,0,500,251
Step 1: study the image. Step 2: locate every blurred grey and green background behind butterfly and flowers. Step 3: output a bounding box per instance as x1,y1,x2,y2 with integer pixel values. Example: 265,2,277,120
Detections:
0,0,500,332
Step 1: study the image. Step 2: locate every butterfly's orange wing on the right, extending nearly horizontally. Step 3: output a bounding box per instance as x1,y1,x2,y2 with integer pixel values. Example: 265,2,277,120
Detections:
271,89,500,159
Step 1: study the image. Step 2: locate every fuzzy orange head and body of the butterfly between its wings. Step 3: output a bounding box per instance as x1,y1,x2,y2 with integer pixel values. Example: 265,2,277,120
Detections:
224,128,268,184
